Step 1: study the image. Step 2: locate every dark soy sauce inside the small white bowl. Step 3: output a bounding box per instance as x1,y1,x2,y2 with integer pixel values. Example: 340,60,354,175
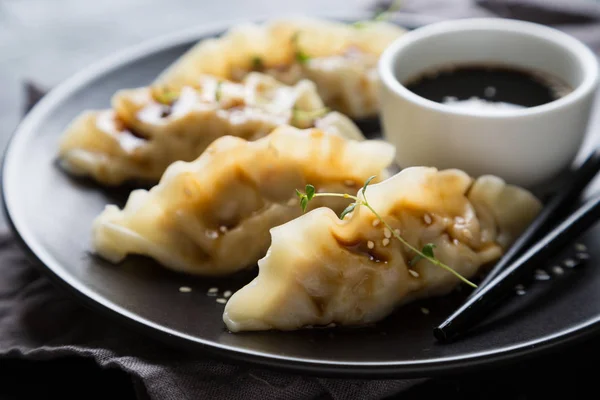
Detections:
404,64,572,109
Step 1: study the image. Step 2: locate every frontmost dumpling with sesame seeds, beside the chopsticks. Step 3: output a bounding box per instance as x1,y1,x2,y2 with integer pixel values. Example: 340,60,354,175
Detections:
223,167,541,332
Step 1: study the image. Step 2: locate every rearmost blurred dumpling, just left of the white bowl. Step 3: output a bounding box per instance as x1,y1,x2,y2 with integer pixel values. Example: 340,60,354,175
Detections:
157,18,405,118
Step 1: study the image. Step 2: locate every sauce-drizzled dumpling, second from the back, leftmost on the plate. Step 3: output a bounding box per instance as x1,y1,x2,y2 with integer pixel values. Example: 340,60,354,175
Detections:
59,73,364,185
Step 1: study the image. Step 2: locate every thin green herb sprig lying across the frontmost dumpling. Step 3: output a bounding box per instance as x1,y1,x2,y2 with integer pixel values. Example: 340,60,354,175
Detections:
296,176,477,288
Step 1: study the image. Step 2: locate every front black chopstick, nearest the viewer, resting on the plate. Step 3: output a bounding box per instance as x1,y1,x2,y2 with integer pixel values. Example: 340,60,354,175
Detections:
433,195,600,342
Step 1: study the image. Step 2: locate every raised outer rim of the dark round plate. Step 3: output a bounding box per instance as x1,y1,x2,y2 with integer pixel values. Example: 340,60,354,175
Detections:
0,14,600,379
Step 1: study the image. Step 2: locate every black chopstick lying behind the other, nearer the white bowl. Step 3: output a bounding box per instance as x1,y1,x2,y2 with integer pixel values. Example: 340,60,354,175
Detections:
471,150,600,296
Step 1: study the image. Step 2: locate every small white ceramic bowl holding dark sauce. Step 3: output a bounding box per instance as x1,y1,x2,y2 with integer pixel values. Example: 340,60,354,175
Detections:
379,18,598,187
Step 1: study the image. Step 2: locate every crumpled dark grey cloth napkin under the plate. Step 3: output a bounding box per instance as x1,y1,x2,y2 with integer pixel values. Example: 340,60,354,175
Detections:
0,0,600,399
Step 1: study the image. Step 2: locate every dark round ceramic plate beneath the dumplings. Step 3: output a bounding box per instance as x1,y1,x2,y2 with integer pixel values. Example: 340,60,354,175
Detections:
2,15,600,378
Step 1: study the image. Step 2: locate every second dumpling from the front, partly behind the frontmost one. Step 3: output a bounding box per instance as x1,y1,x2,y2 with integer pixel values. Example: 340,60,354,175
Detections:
92,126,395,276
